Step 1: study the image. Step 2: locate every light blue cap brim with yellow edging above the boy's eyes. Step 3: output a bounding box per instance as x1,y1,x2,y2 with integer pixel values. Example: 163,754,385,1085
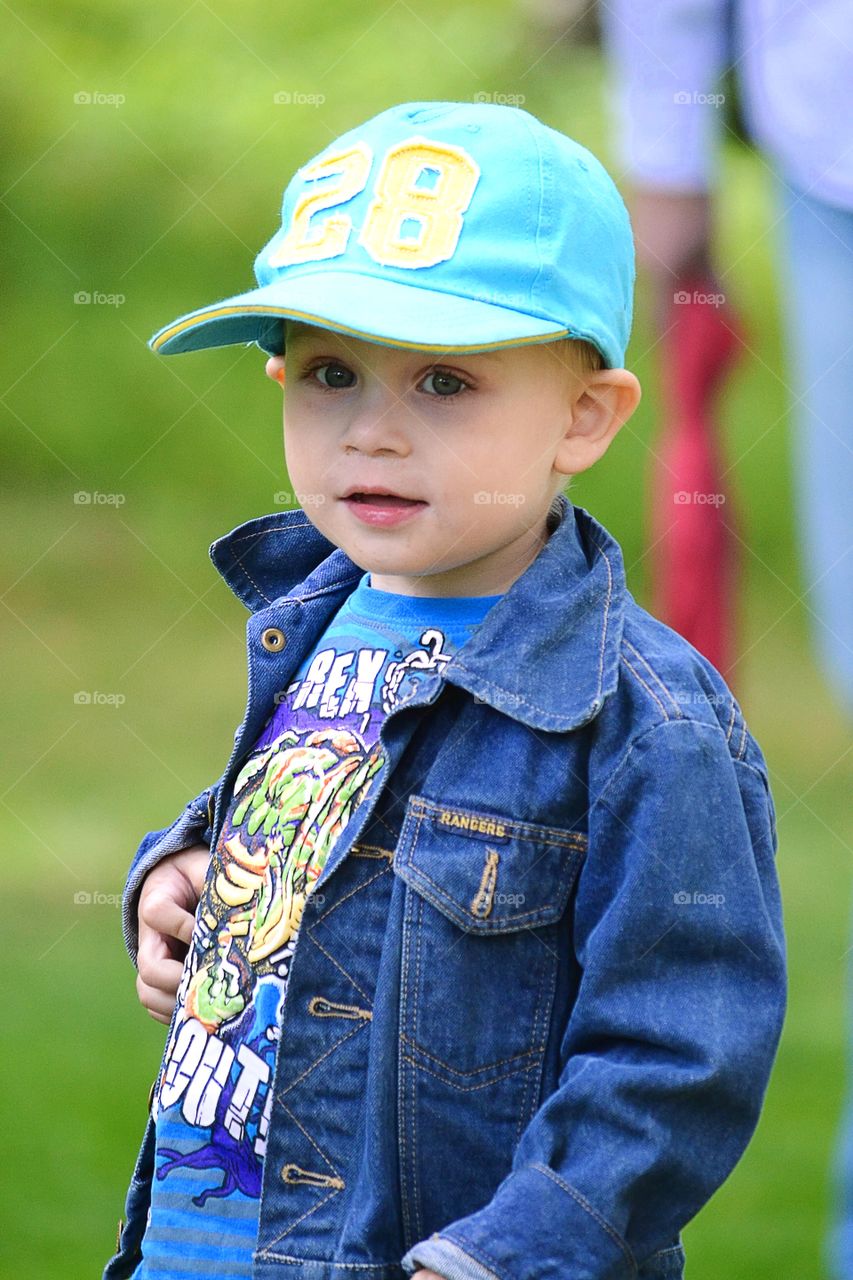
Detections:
149,270,575,356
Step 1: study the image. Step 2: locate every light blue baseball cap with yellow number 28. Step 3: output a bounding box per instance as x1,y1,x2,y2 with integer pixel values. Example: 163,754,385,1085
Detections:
149,102,634,367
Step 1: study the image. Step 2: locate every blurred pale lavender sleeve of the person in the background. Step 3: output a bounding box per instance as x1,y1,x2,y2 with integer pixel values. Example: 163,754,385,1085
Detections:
601,0,733,192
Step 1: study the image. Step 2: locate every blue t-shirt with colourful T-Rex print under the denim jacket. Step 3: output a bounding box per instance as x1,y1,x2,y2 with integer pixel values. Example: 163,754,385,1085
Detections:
133,573,500,1280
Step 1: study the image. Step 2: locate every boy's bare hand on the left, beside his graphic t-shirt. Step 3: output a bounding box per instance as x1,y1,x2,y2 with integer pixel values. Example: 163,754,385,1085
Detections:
136,845,210,1027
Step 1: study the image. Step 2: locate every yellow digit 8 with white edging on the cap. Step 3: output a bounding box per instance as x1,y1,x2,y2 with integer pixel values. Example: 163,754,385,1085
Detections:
359,138,480,266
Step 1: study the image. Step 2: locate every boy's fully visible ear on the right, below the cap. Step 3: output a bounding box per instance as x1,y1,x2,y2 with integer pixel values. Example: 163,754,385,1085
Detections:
553,369,642,476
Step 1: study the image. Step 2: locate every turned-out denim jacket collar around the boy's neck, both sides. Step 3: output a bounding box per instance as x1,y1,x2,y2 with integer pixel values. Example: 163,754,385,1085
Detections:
210,494,628,732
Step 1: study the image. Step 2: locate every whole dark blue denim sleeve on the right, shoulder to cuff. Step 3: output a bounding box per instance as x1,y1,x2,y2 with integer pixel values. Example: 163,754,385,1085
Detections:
402,718,786,1280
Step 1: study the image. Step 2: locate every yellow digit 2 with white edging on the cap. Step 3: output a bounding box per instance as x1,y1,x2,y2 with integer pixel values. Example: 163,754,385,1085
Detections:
269,142,373,266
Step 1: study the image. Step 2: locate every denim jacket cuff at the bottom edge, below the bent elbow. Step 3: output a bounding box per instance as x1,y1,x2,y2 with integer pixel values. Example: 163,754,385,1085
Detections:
402,1164,637,1280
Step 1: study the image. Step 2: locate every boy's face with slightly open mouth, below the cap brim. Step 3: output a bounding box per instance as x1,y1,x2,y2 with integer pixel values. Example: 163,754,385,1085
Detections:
266,321,631,596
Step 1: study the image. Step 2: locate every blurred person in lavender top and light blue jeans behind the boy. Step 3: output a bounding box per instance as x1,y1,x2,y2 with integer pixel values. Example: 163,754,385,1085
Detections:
599,0,853,1280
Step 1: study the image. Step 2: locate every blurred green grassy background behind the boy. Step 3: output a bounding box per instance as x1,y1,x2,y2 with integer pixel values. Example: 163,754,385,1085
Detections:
0,0,853,1280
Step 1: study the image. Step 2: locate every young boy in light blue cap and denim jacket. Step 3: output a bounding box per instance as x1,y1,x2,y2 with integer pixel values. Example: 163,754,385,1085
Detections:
105,102,785,1280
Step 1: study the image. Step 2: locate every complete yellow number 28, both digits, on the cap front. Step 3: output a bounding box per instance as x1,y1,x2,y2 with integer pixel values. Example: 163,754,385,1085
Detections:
269,138,480,266
